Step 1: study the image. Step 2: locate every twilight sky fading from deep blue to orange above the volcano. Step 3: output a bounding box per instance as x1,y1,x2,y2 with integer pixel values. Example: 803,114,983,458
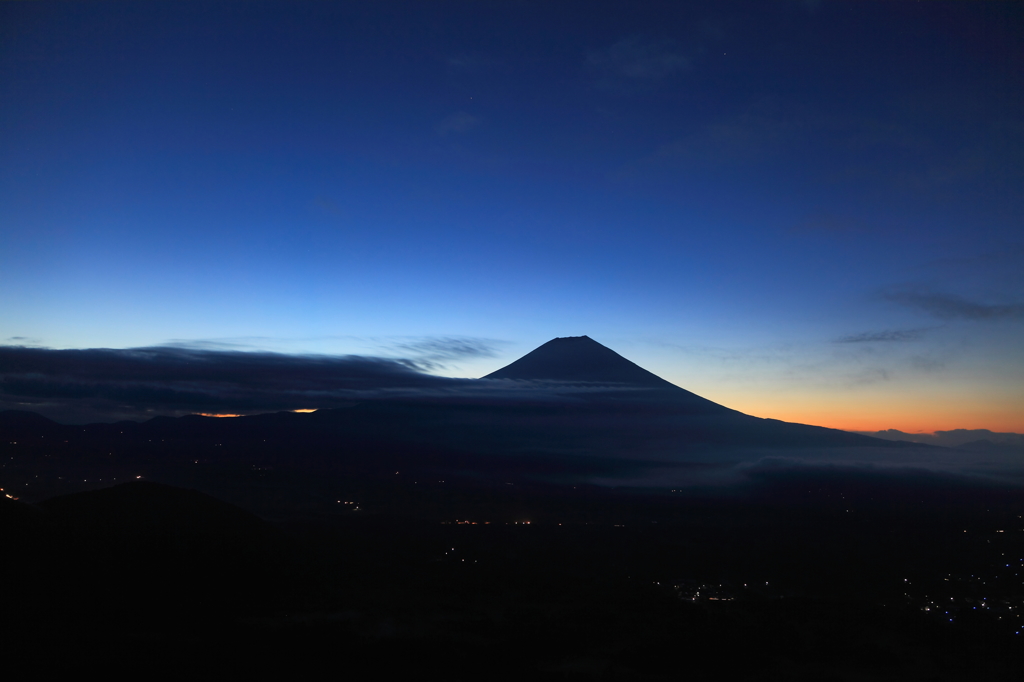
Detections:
0,1,1024,432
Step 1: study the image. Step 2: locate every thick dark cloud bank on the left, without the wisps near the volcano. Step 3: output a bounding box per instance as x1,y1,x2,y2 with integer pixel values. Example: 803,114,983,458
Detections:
0,346,461,420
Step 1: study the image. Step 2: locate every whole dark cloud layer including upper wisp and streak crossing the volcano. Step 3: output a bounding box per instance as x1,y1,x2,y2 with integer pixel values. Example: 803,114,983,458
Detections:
0,338,655,423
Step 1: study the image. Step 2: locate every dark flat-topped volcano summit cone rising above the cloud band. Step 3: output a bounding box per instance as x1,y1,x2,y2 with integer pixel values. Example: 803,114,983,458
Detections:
484,336,678,388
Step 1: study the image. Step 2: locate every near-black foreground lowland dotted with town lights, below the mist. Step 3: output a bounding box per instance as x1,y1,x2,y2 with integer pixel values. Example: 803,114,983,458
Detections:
0,469,1024,682
